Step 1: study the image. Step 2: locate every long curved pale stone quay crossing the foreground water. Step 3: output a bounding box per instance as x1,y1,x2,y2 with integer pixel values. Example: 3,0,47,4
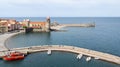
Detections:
0,45,120,64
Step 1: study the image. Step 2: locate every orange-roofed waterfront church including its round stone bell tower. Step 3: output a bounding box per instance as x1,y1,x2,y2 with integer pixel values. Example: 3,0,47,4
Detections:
21,17,50,32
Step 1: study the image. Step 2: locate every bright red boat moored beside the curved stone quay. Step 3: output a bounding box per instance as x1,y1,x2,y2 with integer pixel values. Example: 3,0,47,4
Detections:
3,52,24,61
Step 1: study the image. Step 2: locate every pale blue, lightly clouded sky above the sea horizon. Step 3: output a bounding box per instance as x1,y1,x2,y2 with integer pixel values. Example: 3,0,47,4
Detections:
0,0,120,17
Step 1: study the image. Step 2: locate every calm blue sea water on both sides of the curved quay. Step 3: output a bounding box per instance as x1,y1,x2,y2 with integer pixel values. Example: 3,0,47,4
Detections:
0,17,120,67
